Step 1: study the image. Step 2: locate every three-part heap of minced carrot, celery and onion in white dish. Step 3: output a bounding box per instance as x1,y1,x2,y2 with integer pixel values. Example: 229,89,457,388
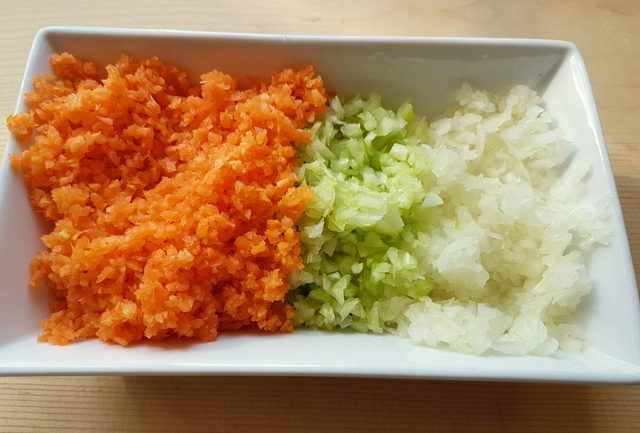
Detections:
7,53,609,355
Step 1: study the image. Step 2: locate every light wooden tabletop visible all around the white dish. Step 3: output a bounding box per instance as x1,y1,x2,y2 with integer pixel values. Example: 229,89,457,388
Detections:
0,0,640,433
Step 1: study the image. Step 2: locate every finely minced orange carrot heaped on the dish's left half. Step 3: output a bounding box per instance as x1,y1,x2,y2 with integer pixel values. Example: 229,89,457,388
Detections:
7,53,326,345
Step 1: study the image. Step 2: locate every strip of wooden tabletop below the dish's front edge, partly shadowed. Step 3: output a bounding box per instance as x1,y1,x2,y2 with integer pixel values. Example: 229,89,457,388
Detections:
0,377,640,433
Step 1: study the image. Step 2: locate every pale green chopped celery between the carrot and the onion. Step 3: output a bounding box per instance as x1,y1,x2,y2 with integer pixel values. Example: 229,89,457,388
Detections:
293,94,442,333
